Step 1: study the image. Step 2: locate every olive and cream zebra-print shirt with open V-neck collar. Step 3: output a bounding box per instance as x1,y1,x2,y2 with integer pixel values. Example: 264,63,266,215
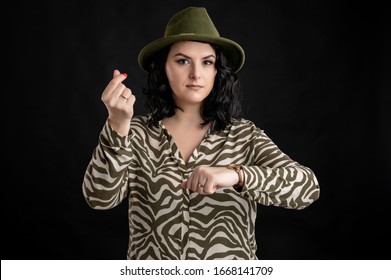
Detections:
82,116,319,260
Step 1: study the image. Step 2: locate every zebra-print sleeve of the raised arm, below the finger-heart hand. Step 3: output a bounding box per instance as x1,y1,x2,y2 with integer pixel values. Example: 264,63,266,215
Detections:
82,121,133,209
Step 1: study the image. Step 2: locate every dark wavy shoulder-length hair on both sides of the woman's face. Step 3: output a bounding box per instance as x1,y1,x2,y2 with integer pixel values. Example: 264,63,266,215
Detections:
142,45,242,130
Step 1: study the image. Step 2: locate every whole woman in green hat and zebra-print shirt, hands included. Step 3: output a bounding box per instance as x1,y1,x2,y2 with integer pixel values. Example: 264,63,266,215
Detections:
83,7,319,259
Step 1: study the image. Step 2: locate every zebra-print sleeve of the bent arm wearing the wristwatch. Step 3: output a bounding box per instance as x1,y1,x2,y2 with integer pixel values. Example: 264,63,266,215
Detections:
242,123,320,210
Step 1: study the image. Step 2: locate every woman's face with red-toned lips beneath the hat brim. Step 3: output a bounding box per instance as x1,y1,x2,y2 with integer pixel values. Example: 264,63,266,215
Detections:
165,41,217,107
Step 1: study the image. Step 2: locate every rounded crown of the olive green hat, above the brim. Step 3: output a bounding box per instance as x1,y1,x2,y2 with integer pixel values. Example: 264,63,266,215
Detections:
164,7,220,37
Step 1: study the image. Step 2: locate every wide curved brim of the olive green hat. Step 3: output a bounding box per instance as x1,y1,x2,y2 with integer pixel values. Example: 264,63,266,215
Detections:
138,34,245,72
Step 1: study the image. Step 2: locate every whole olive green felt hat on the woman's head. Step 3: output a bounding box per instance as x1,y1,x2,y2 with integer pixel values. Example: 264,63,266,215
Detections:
138,7,245,72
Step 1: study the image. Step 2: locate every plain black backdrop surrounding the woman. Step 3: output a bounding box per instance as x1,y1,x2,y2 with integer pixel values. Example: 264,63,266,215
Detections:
1,0,391,259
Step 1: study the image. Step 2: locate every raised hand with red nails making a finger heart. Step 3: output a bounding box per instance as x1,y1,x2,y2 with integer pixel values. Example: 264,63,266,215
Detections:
101,70,136,136
